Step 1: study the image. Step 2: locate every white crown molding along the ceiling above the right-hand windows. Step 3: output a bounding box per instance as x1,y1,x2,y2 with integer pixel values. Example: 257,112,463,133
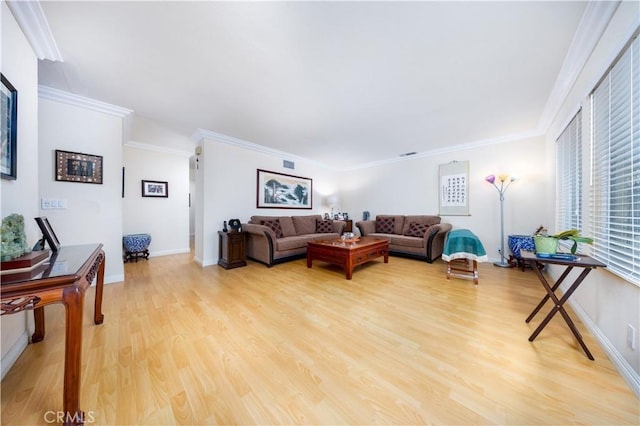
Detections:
538,1,620,133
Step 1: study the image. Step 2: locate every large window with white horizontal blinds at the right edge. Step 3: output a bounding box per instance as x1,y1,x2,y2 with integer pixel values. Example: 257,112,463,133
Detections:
590,33,640,285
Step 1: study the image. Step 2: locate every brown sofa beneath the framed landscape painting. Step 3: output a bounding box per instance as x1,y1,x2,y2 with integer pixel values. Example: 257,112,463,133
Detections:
242,214,346,267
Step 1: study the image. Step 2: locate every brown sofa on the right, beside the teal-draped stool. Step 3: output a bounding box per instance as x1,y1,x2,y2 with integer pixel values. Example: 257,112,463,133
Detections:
356,215,451,263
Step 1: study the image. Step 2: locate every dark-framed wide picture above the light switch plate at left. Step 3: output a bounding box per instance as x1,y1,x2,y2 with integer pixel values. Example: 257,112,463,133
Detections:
55,149,103,185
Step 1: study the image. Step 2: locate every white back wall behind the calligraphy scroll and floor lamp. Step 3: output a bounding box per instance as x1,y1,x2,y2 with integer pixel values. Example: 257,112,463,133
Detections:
340,137,553,261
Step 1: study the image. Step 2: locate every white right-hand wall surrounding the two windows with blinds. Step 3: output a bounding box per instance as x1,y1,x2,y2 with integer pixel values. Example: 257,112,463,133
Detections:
546,2,640,396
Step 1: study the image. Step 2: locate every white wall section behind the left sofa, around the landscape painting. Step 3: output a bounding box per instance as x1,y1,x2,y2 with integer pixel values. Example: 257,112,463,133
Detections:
195,133,337,266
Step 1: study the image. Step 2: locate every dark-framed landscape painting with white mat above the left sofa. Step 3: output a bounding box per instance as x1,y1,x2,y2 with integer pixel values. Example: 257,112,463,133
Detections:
256,169,313,210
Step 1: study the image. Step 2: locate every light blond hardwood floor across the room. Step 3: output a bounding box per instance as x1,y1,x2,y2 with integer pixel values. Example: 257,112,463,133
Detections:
1,254,640,425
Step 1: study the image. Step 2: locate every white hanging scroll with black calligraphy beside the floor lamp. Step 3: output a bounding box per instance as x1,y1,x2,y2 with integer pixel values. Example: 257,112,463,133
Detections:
438,161,469,216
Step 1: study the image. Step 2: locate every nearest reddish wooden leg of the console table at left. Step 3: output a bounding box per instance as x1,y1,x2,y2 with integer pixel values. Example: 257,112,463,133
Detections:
62,286,84,425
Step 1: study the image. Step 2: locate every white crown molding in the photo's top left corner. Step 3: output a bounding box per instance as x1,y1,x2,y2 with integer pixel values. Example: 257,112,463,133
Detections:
6,0,63,62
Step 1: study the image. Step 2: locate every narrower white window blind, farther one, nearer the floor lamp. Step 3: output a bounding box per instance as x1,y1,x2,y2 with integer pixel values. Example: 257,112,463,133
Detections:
556,111,582,232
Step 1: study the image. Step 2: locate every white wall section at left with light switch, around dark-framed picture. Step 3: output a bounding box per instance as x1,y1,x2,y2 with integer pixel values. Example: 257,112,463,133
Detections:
39,96,124,283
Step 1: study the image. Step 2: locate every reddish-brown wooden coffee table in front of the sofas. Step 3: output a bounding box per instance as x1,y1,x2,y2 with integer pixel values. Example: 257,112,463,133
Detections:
307,237,389,280
